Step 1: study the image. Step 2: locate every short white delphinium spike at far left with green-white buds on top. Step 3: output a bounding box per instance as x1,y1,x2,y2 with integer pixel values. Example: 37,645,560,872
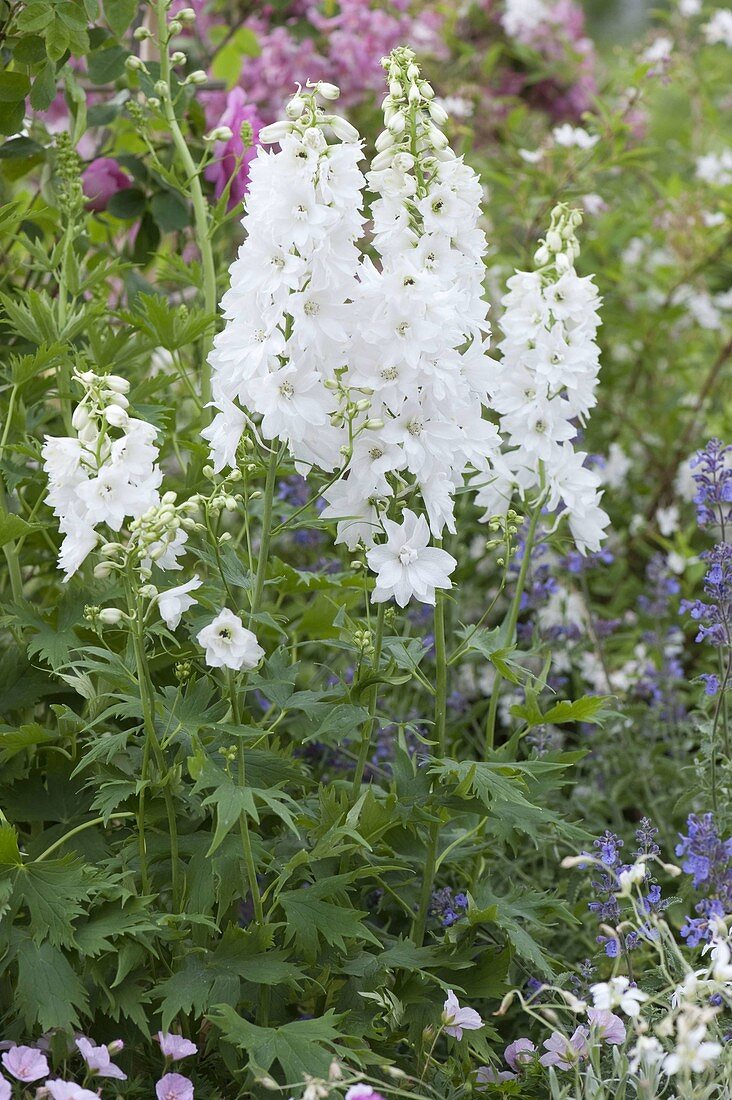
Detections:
43,371,163,580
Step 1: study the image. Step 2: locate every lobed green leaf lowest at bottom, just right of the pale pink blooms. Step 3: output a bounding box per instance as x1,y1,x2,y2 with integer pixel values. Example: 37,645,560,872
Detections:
208,1004,348,1081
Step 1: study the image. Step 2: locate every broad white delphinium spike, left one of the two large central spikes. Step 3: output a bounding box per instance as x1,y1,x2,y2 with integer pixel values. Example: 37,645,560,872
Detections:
203,77,364,471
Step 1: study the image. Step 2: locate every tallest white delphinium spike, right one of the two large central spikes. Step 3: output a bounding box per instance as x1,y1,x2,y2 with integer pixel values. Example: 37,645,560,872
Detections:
323,41,499,563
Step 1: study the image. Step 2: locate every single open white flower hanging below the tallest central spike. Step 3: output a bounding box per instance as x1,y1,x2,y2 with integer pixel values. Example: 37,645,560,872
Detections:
367,508,457,607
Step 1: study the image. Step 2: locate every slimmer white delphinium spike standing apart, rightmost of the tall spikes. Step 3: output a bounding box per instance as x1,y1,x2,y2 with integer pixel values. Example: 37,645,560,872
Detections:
474,206,609,553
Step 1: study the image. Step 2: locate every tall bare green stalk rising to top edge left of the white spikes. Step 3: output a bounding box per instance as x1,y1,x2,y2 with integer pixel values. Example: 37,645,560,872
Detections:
156,0,217,405
